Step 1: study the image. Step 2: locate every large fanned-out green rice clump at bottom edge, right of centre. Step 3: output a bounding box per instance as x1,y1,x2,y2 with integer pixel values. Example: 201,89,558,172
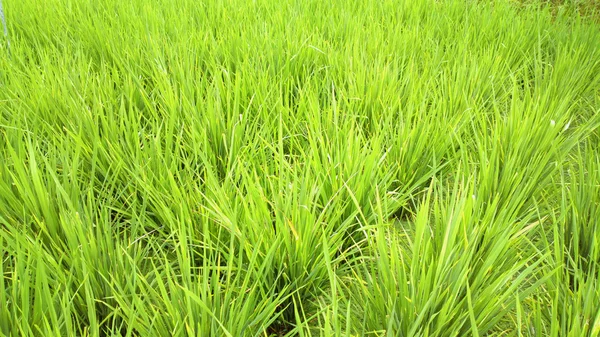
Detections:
348,173,544,336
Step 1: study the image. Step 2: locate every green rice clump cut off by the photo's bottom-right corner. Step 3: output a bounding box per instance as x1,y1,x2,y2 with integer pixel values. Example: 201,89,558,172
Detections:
522,145,600,336
